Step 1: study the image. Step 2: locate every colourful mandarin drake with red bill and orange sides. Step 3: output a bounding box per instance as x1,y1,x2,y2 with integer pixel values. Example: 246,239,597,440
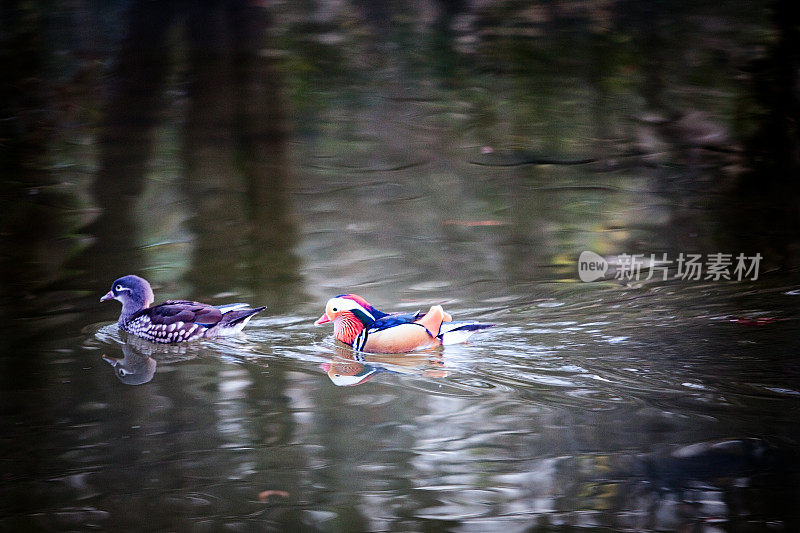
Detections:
314,294,493,353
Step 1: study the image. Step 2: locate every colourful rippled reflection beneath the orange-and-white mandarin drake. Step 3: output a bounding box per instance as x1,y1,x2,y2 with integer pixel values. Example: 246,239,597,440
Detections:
320,348,447,387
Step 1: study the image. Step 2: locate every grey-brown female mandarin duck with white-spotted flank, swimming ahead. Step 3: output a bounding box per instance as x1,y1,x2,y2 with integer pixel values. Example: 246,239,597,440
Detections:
100,275,266,344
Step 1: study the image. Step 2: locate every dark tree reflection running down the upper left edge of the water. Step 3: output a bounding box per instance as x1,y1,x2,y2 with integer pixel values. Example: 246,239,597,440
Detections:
0,2,59,335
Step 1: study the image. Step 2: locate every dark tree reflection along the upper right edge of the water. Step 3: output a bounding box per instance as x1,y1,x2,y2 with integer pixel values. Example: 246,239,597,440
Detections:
723,0,800,269
